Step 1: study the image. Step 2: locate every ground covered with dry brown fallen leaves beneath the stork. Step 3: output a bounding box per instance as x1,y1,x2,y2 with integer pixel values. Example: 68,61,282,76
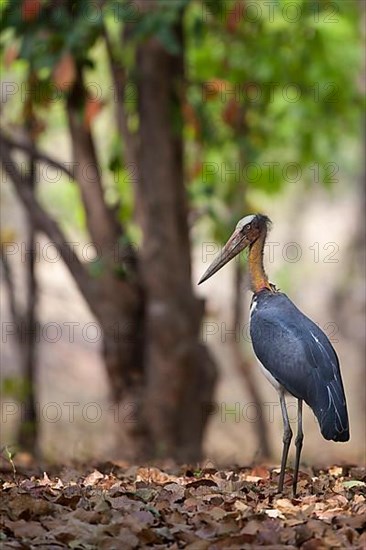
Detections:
0,460,366,550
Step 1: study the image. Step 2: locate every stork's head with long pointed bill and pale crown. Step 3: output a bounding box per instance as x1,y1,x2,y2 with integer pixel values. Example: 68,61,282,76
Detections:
198,214,270,285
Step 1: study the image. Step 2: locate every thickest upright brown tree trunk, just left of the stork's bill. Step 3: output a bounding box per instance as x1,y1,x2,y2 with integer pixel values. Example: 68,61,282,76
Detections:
137,17,216,462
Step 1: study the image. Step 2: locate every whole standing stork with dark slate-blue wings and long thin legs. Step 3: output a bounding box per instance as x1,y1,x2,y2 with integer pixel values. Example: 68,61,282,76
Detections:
199,214,349,495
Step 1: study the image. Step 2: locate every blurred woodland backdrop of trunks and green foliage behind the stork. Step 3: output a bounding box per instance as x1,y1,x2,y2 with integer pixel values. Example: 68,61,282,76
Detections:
1,0,366,470
